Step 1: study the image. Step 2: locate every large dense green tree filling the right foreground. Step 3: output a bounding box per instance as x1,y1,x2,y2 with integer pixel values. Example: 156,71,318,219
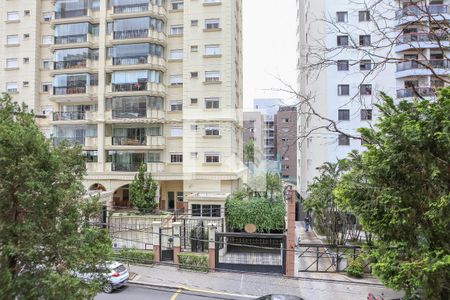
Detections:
335,88,450,299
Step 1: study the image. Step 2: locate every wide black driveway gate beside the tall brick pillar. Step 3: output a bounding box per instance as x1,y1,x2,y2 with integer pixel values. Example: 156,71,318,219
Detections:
216,232,286,274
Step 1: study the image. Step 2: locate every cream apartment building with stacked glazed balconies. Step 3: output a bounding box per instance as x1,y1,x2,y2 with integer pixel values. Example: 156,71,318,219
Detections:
0,0,244,217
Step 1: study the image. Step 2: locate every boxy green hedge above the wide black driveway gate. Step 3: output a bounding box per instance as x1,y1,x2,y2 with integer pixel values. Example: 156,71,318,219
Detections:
225,197,286,232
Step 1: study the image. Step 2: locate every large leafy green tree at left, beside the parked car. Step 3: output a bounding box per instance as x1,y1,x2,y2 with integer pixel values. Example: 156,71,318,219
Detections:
0,95,111,299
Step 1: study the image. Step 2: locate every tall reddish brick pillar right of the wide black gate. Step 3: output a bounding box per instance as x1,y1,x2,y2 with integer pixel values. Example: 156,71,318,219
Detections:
285,190,296,276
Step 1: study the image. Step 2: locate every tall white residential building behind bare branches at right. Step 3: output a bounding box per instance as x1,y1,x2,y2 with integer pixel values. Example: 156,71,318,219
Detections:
297,0,450,196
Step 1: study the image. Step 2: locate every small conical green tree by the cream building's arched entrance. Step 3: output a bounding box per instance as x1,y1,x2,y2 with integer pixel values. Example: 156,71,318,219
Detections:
130,164,158,213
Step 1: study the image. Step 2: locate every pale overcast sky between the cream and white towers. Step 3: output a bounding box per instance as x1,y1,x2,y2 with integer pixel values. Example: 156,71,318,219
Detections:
243,0,297,108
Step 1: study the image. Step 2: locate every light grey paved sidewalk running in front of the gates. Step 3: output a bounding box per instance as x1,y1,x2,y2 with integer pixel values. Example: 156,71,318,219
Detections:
125,265,400,300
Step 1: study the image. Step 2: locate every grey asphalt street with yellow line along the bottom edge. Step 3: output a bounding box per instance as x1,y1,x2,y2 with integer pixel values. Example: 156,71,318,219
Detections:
94,284,255,300
